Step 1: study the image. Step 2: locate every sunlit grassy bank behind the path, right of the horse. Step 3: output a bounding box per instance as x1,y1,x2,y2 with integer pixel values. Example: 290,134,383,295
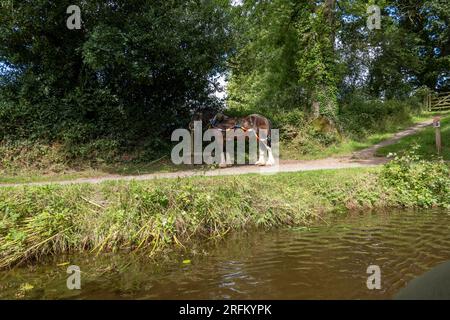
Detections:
250,97,433,160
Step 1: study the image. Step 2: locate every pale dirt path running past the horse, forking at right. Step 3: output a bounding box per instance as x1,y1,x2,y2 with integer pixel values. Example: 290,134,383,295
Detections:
0,120,433,187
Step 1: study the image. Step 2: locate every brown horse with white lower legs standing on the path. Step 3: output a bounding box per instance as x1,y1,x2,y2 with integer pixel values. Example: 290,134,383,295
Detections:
189,113,275,168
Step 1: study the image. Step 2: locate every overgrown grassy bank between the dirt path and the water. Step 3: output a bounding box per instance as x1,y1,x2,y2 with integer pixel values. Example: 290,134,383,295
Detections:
0,159,450,268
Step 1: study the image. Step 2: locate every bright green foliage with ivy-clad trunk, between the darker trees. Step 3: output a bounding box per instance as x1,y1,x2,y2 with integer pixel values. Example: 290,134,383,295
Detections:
228,0,337,115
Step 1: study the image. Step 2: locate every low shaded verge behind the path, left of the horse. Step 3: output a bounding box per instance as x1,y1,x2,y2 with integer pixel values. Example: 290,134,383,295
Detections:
0,141,204,183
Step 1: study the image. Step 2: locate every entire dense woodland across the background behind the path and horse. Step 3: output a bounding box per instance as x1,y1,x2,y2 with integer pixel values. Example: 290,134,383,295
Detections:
0,0,450,161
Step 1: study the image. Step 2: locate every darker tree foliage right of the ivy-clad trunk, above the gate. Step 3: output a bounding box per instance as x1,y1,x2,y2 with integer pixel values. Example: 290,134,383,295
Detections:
337,0,450,99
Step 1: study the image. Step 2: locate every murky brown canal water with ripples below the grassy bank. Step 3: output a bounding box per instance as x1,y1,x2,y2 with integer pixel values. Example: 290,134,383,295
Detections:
0,211,450,299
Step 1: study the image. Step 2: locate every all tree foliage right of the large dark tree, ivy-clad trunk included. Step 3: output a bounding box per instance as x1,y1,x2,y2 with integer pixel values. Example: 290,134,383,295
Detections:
228,0,450,116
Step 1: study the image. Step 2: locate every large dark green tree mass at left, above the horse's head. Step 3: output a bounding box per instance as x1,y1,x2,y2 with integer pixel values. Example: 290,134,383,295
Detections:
0,0,231,158
